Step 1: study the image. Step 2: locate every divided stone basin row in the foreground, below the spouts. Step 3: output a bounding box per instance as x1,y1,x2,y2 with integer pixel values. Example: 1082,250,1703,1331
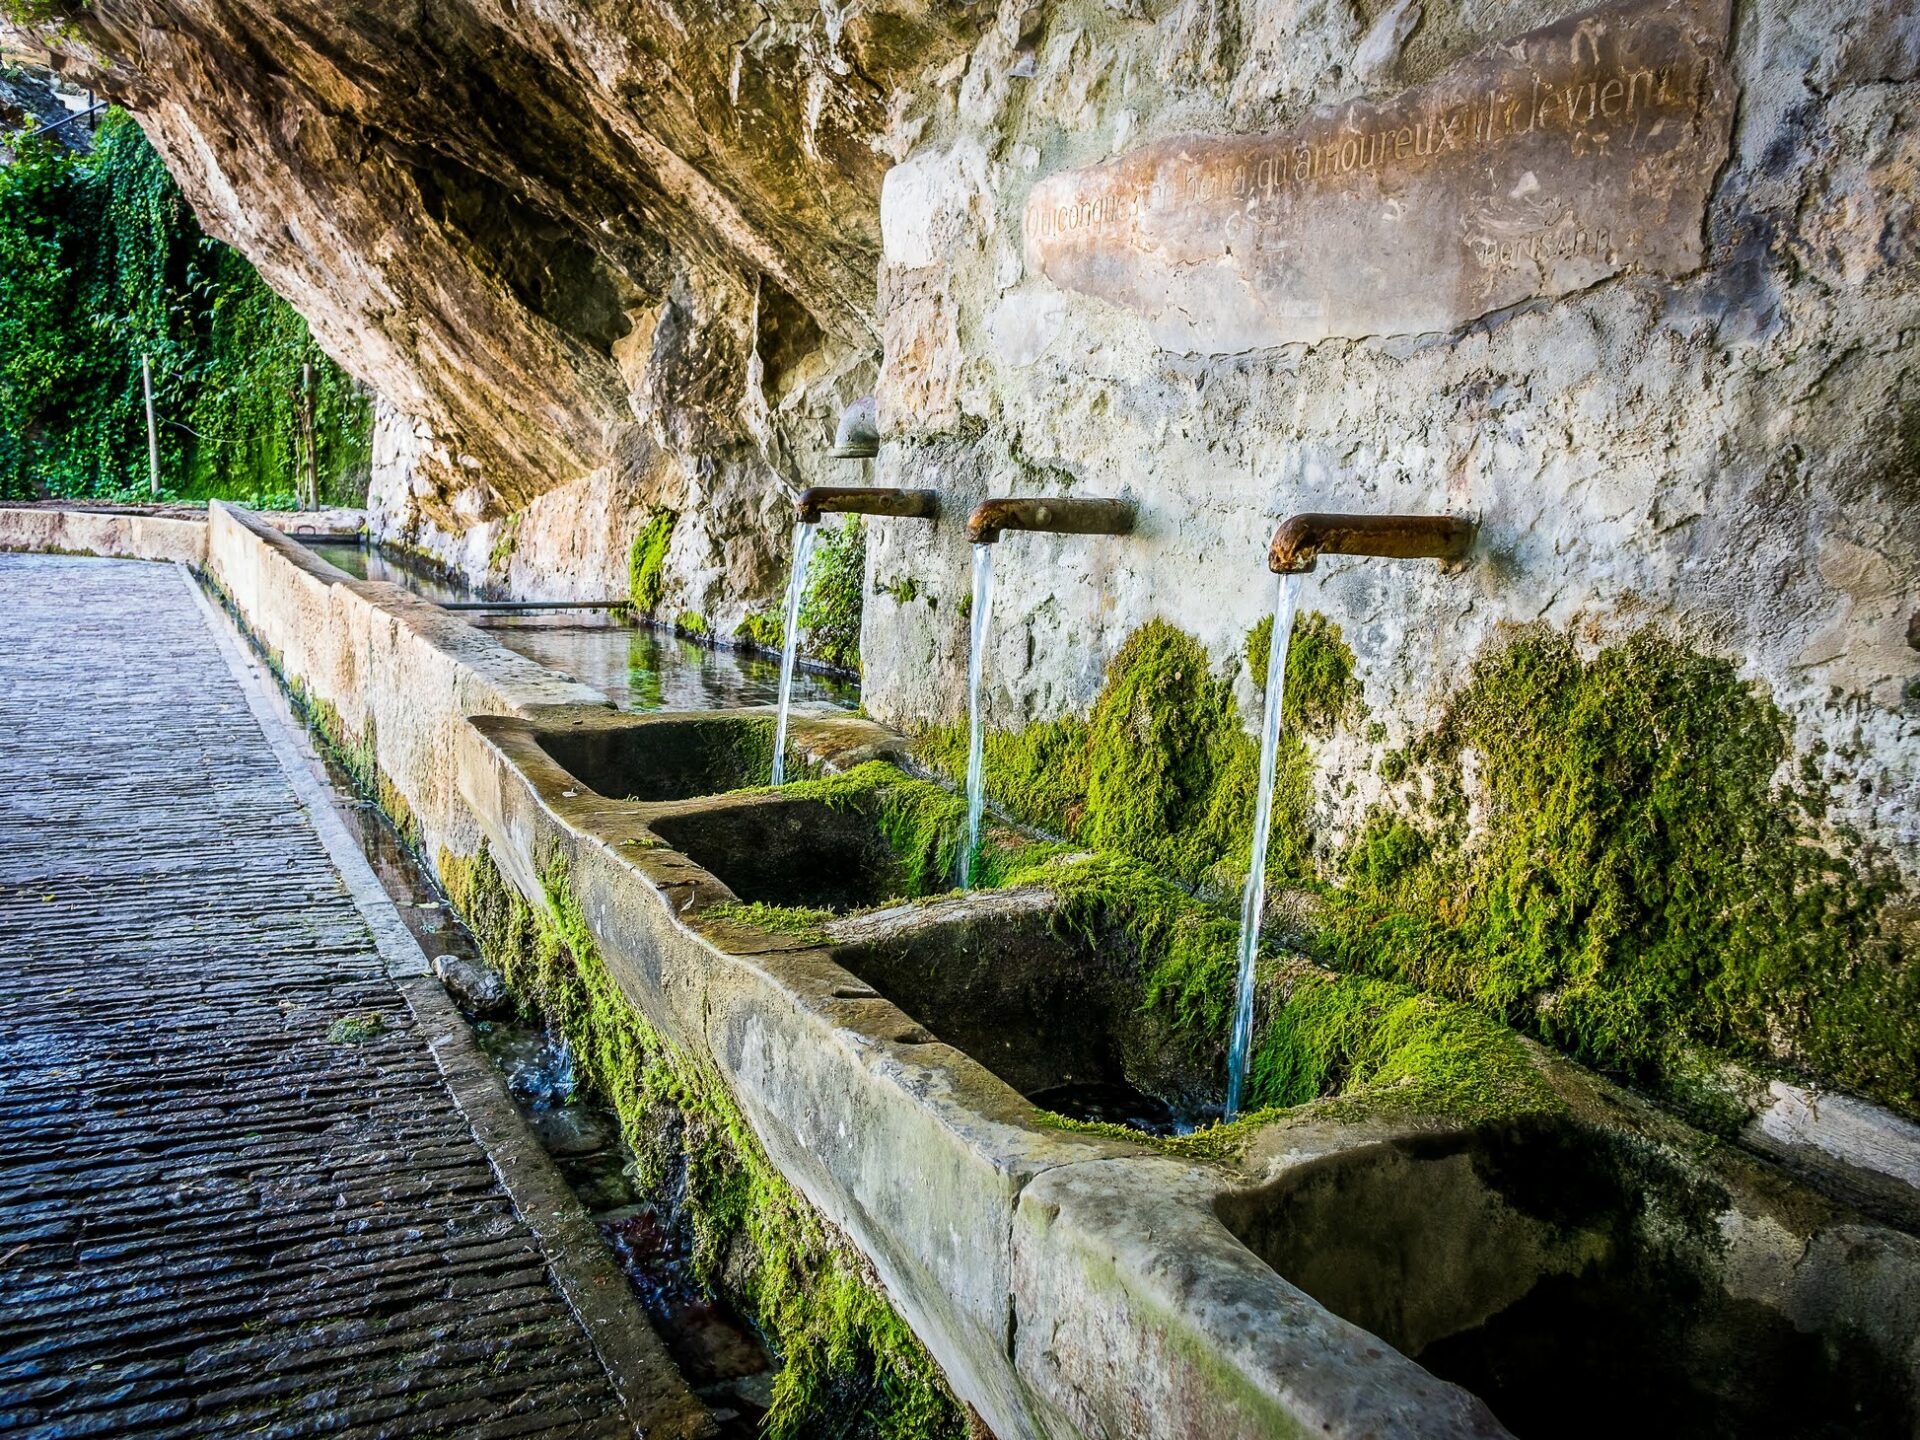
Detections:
459,707,1920,1440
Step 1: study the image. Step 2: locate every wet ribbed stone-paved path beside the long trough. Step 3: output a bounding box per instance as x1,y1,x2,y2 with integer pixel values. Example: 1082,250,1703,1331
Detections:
0,557,628,1436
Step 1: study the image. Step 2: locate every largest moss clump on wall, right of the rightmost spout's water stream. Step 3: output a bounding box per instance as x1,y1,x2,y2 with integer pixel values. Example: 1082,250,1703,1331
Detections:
1327,628,1920,1112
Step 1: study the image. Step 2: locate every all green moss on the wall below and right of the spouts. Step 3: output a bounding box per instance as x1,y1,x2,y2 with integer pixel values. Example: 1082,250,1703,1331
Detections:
918,614,1920,1114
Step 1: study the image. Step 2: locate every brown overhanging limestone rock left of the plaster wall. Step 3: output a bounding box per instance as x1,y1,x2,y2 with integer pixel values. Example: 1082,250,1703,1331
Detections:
15,0,968,534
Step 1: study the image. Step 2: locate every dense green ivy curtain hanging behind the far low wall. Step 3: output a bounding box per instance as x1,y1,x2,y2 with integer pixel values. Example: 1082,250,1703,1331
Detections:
0,111,372,505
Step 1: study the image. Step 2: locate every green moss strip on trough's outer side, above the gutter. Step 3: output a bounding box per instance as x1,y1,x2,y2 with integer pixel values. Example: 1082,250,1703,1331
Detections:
440,852,966,1440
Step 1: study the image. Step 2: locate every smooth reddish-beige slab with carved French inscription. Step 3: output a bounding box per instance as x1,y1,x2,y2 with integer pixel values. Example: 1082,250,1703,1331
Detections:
1025,0,1734,353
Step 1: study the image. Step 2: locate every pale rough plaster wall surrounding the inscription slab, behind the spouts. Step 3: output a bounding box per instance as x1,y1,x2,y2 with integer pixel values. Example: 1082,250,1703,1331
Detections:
866,0,1920,868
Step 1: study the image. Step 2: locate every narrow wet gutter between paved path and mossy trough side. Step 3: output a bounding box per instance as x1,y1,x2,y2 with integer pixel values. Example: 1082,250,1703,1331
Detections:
282,683,774,1440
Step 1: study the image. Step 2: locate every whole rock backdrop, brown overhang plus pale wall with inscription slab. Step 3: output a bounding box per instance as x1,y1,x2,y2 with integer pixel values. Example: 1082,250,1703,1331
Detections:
18,0,1920,876
